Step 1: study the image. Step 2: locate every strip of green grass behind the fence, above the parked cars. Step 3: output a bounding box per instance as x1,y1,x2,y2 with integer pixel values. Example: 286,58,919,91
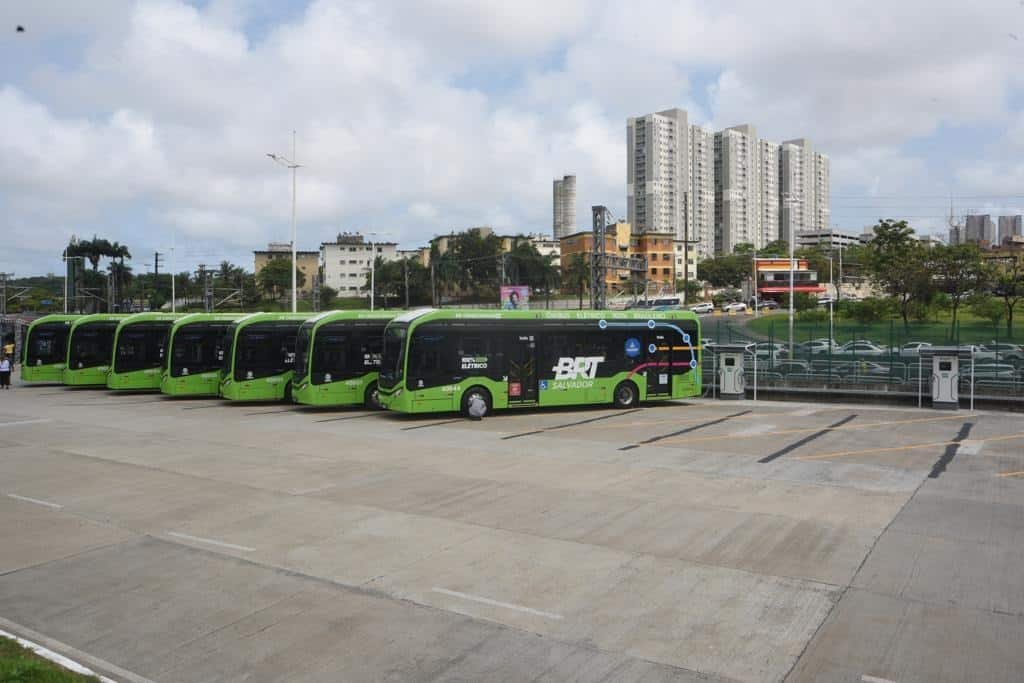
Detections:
745,313,1024,346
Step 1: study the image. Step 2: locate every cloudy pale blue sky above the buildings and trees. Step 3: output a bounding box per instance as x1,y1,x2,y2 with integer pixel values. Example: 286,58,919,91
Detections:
0,0,1024,275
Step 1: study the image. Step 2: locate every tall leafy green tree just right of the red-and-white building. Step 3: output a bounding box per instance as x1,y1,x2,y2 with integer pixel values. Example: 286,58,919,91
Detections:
864,219,932,331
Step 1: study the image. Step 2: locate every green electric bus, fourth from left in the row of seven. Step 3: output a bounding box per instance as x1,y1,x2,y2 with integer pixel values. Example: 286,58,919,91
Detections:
160,313,243,396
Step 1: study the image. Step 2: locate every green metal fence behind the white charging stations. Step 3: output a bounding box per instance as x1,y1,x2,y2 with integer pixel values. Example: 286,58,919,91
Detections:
702,318,1024,399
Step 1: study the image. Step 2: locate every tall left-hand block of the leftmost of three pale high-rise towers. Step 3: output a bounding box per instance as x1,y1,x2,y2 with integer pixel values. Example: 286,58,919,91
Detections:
626,109,691,239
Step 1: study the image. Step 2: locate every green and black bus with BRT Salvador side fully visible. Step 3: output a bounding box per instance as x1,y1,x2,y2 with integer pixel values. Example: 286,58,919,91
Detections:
378,309,700,413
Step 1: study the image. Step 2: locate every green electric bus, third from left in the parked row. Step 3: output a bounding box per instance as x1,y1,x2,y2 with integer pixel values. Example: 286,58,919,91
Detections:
106,313,181,391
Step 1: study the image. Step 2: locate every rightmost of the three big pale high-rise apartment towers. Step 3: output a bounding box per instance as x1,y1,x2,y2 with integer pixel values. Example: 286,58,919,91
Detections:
779,138,831,242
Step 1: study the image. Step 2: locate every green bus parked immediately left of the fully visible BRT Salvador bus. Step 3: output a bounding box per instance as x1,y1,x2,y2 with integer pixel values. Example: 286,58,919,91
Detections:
292,310,395,408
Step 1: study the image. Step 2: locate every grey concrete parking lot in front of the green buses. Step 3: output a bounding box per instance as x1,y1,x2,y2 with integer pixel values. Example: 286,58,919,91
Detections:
0,387,1024,682
